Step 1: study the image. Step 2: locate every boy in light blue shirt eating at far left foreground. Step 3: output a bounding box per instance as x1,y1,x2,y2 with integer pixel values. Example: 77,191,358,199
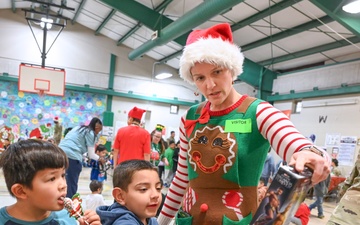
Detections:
0,139,100,225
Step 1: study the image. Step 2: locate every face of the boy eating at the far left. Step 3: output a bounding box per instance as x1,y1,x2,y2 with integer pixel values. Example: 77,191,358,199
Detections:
24,168,67,213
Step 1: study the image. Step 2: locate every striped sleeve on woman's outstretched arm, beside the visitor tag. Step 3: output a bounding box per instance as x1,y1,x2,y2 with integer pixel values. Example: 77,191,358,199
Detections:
256,102,313,162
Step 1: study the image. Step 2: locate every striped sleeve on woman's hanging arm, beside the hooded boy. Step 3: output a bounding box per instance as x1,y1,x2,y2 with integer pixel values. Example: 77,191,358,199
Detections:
158,113,189,225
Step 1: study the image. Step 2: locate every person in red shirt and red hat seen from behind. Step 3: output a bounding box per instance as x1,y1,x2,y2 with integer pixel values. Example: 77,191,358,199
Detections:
113,107,150,166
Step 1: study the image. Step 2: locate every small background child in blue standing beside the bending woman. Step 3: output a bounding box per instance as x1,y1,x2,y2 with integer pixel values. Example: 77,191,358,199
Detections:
88,144,107,182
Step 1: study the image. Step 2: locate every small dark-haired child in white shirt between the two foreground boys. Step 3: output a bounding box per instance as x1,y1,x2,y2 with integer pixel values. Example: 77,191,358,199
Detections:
85,180,106,210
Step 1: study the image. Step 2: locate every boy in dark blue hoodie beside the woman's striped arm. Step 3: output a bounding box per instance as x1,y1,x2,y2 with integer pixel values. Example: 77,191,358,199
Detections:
96,159,162,225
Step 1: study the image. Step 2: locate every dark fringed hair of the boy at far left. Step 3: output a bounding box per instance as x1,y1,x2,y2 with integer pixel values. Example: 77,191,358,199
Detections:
0,139,69,196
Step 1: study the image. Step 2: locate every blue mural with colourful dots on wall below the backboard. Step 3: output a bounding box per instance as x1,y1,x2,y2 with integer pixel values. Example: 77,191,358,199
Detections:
0,81,106,140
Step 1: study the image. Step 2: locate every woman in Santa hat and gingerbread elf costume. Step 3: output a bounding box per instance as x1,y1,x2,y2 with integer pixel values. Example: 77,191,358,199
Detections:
158,24,330,225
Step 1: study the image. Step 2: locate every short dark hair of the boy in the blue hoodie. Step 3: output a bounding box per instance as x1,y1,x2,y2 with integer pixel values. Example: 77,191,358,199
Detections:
113,159,157,191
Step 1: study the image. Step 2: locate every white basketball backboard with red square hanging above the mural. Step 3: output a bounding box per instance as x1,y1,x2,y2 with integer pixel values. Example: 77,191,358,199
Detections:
19,63,65,96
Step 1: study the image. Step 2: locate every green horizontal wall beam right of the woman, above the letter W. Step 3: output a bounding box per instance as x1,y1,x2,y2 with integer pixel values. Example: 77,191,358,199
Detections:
266,85,360,102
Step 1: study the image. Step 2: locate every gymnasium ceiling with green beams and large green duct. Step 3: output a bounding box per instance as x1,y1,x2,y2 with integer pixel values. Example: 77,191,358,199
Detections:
0,0,360,77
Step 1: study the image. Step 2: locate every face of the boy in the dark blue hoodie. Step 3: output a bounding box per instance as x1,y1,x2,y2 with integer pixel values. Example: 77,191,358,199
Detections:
123,170,162,224
